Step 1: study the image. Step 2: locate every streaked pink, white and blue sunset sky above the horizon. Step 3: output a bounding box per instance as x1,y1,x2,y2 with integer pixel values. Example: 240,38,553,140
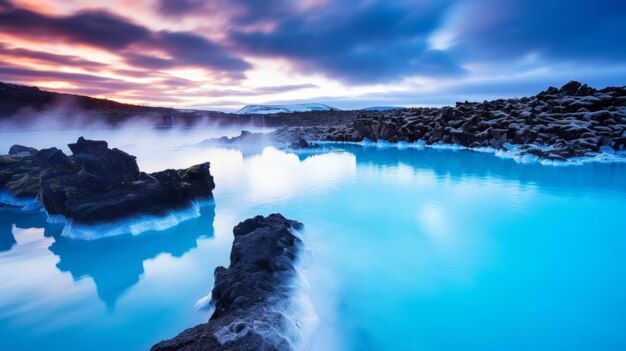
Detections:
0,0,626,111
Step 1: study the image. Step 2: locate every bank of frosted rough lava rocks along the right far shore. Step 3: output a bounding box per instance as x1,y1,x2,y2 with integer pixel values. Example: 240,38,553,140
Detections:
274,81,626,160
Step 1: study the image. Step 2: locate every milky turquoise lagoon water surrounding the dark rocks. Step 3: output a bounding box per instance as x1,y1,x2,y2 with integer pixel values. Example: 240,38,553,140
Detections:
0,131,626,350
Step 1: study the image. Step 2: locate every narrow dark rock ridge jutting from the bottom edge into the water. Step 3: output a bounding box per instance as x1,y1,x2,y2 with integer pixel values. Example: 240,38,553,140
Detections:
152,214,303,351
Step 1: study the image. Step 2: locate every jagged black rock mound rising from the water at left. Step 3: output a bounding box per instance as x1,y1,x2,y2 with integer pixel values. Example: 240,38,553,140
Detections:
0,137,215,224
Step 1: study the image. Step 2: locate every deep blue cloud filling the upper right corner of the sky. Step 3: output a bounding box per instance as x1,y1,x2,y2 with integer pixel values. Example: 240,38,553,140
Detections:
452,0,626,63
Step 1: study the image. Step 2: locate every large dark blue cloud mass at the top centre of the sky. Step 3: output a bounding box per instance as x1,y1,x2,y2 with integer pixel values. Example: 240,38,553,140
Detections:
158,0,464,84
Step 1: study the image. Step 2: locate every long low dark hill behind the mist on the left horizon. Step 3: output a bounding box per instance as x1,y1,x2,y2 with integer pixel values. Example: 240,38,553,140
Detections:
0,82,358,131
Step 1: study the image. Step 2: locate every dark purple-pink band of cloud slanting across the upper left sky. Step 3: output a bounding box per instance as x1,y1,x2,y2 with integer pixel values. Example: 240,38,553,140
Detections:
0,2,251,75
